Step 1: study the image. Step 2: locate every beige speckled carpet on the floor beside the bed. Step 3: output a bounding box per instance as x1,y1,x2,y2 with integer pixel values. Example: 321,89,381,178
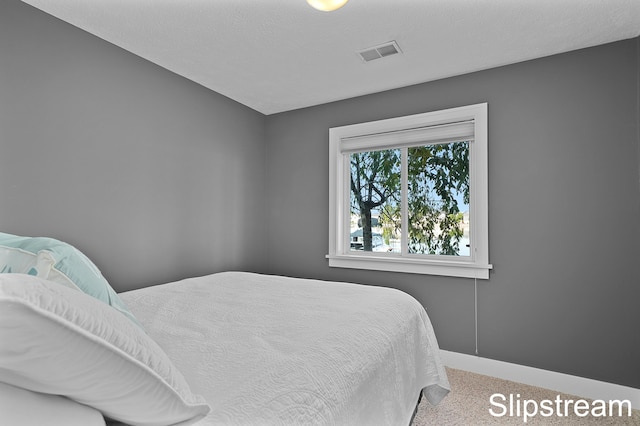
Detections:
413,368,640,426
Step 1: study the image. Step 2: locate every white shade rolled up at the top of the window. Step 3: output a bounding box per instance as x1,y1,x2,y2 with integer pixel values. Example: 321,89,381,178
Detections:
340,120,475,153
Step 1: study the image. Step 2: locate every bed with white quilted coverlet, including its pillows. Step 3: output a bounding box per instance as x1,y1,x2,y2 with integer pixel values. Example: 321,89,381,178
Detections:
0,234,449,426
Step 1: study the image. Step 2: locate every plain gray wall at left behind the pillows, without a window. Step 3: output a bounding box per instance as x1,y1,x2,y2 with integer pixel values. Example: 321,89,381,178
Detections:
0,0,266,291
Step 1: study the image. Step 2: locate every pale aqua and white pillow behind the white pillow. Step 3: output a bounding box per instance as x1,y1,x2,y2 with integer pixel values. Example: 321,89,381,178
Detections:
0,232,142,327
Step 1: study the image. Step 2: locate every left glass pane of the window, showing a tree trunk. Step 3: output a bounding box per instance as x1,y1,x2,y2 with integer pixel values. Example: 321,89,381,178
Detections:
350,149,401,253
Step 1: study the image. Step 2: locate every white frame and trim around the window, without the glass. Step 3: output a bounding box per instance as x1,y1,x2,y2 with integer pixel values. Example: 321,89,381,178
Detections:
327,103,492,279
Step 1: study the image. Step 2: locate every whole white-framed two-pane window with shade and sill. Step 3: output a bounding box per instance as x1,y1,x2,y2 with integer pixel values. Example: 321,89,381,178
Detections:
327,104,491,279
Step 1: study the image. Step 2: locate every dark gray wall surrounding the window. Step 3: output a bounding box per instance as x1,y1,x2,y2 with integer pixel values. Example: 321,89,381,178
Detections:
267,39,640,387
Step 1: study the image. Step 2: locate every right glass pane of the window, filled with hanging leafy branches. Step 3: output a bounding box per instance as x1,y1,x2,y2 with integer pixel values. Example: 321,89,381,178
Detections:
407,142,470,256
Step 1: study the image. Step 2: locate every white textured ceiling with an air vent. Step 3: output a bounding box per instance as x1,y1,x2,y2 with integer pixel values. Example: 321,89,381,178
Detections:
23,0,640,114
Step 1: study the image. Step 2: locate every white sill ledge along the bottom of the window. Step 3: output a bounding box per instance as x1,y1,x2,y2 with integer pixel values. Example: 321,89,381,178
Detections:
326,254,493,279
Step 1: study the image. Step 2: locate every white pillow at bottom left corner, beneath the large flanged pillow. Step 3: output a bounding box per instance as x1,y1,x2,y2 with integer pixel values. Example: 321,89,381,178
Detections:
0,382,105,426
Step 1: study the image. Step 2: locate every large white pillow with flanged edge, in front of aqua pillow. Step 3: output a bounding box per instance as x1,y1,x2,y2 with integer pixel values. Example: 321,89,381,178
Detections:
0,274,209,426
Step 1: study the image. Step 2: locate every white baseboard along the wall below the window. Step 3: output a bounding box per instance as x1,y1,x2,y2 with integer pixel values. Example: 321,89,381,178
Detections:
440,350,640,409
